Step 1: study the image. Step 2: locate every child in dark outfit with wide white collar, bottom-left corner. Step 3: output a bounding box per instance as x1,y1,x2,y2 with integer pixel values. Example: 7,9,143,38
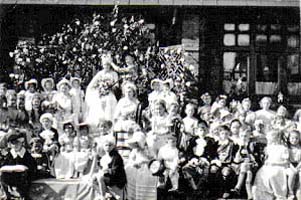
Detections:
0,132,37,200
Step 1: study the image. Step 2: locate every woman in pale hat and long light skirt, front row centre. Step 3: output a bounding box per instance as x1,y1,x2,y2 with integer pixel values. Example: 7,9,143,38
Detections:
125,131,157,200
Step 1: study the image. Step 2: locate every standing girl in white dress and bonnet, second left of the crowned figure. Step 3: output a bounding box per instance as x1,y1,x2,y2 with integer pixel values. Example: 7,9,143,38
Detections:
52,78,74,132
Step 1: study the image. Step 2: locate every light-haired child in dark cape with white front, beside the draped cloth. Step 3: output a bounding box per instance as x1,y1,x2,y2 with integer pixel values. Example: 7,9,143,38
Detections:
92,136,127,200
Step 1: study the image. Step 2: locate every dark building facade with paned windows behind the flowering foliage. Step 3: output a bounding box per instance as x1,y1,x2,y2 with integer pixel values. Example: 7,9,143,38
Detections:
0,0,301,105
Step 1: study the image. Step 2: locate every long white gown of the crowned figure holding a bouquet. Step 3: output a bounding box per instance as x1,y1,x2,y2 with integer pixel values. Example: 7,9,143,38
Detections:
85,70,118,129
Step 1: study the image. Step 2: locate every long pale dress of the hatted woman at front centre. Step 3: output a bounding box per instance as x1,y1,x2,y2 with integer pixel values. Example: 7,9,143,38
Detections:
125,148,157,200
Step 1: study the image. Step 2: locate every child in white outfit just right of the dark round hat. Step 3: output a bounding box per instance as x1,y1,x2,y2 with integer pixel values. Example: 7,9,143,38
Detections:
158,135,179,191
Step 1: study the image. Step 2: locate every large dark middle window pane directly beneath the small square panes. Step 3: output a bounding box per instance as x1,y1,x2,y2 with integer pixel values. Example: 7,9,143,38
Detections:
256,54,279,82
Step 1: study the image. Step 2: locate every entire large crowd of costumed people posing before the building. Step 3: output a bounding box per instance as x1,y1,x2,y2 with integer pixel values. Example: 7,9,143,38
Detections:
0,54,301,200
